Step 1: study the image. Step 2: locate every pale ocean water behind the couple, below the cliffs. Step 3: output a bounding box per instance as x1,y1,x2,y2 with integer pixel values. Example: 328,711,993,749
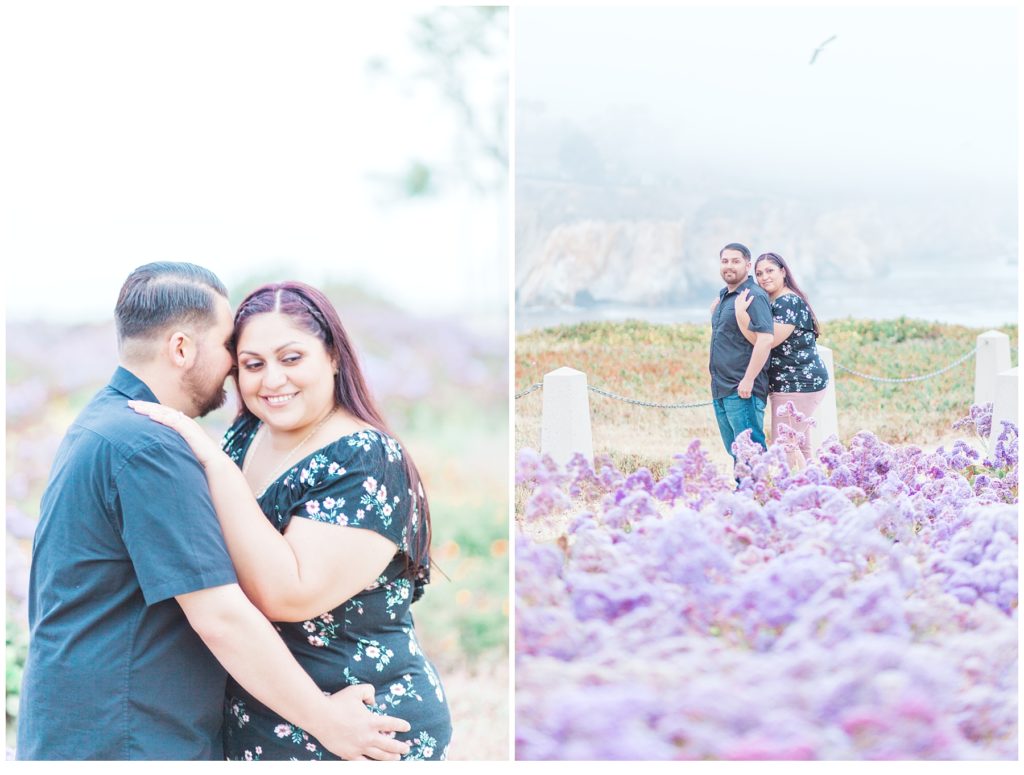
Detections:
515,259,1020,333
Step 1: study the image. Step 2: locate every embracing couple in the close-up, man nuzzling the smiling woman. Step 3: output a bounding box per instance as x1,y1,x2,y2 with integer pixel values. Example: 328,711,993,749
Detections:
17,263,452,760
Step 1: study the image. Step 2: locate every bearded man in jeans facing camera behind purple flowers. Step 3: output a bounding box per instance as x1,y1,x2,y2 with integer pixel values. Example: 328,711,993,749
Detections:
709,243,774,460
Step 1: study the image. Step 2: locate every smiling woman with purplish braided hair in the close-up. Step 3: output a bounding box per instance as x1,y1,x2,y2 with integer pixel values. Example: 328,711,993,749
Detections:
134,282,452,760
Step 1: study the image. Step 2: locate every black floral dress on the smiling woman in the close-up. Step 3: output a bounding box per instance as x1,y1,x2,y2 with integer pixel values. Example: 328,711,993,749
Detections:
223,416,452,760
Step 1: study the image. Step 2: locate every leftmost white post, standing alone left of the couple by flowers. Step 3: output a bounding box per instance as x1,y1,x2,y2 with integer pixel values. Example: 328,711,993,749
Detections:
541,367,594,466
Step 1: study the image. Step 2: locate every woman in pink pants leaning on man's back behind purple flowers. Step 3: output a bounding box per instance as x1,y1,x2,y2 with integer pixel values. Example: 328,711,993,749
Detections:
736,253,828,465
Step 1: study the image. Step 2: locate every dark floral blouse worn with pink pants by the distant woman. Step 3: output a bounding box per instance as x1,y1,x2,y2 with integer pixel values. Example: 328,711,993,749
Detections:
768,293,828,393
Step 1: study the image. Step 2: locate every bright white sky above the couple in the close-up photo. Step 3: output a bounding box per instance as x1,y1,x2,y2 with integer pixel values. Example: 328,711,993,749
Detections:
0,0,508,319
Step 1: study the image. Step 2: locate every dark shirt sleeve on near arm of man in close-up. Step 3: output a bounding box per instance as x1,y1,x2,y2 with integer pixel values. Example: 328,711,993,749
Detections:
115,434,238,605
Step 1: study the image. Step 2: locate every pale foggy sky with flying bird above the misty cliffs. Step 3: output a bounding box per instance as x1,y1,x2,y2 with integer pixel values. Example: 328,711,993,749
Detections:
516,6,1019,191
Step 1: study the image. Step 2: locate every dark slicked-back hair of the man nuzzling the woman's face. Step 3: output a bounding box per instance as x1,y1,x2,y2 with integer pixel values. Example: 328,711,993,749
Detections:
114,261,227,346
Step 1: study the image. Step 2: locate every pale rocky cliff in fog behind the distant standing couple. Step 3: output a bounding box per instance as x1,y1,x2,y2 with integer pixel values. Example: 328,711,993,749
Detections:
516,181,905,308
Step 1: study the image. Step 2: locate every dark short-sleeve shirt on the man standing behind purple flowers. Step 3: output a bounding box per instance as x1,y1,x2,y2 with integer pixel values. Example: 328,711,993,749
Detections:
710,275,775,400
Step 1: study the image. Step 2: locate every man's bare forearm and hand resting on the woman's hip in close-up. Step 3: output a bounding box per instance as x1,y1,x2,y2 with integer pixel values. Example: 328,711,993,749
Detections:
175,584,410,761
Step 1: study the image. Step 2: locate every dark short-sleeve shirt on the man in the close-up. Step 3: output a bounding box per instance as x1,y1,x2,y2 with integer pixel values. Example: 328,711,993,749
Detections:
17,369,237,760
